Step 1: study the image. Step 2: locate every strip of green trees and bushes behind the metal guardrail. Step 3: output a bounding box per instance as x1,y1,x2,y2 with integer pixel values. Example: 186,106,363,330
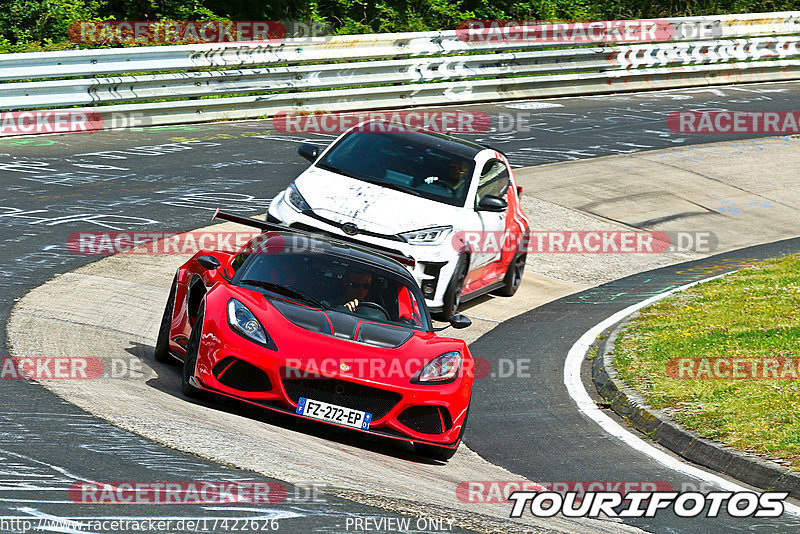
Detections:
0,0,800,51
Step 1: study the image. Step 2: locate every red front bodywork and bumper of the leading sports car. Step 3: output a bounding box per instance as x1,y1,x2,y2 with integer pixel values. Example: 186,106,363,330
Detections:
186,286,472,448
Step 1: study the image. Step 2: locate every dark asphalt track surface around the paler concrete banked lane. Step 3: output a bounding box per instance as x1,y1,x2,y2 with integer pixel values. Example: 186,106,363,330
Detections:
0,83,800,532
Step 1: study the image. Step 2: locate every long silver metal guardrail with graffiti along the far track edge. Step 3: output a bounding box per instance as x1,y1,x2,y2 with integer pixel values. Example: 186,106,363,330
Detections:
0,12,800,128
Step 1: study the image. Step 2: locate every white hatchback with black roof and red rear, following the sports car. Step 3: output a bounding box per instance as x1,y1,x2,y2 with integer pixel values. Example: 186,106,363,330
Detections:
267,123,529,320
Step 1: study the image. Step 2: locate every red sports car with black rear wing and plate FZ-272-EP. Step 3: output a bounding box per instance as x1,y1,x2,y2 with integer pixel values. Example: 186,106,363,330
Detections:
155,213,473,460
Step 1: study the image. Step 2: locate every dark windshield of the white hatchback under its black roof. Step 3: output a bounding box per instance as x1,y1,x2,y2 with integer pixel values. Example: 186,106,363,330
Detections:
316,131,475,206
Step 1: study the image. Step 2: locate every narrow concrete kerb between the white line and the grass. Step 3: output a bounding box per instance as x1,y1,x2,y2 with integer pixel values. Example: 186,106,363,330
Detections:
592,312,800,498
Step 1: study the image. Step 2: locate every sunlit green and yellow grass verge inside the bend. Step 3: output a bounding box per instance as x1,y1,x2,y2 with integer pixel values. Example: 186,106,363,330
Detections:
614,255,800,469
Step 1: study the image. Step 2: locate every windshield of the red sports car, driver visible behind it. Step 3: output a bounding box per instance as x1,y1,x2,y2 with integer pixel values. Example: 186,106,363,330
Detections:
234,252,430,330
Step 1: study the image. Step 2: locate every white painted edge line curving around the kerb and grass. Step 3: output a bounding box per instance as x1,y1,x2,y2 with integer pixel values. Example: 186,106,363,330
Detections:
564,271,800,516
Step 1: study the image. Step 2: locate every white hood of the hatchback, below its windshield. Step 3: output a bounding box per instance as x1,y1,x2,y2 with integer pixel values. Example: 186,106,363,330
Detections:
295,167,463,235
